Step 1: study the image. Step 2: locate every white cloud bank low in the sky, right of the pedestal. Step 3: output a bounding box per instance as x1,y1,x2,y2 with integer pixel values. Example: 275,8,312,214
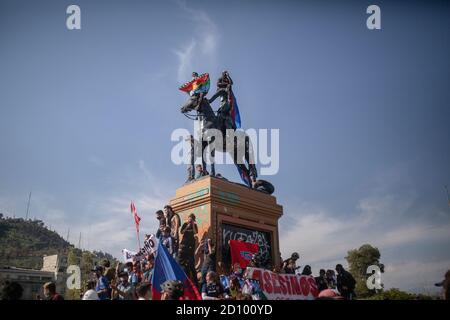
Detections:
280,195,450,292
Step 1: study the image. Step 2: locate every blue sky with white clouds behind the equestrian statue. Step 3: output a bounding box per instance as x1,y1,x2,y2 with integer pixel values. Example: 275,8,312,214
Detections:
0,0,450,292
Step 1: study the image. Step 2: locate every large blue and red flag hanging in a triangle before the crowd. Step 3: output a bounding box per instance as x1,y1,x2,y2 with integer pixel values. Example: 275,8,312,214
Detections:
152,241,202,300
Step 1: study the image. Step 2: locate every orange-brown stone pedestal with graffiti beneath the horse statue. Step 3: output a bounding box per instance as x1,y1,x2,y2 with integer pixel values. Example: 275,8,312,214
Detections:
170,176,283,267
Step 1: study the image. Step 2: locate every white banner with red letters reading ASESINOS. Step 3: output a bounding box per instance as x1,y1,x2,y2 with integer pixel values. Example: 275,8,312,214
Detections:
246,267,319,300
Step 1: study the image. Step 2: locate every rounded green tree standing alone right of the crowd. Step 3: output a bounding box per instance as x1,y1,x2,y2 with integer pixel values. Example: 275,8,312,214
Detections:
345,244,384,298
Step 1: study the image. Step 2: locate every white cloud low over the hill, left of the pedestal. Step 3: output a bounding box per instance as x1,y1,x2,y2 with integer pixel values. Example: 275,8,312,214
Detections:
0,160,174,258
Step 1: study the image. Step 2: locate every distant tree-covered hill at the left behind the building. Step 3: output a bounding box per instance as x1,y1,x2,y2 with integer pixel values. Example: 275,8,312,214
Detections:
0,214,115,270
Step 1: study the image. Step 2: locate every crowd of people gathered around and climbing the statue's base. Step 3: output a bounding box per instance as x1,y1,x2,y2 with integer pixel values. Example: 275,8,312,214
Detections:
65,205,356,300
